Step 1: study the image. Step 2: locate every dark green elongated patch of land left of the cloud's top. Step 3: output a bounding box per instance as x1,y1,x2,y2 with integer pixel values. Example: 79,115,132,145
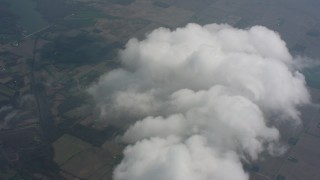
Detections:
41,33,123,66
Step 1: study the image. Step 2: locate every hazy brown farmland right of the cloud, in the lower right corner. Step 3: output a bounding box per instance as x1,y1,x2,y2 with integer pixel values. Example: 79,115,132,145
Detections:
250,89,320,180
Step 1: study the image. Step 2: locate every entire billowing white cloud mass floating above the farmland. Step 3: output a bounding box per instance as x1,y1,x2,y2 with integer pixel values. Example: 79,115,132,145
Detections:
88,24,309,180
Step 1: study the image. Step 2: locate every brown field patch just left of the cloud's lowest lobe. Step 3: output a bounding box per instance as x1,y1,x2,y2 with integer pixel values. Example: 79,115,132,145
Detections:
53,134,120,179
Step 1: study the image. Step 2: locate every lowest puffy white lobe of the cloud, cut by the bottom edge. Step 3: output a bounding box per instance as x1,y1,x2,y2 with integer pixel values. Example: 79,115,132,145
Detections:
115,136,248,180
